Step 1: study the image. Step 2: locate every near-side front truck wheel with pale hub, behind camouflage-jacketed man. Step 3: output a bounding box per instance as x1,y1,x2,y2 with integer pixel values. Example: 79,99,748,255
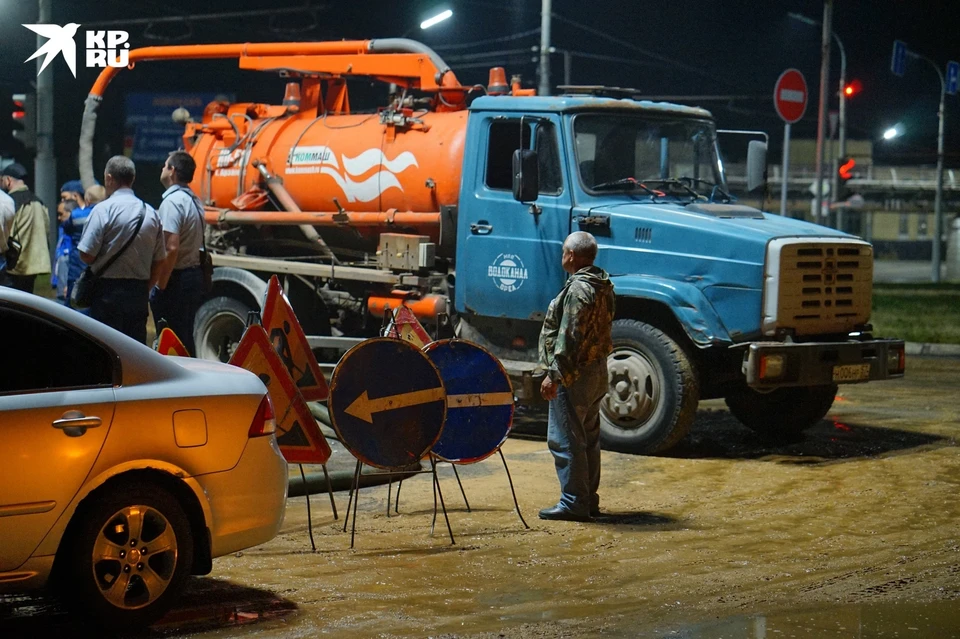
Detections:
600,320,700,454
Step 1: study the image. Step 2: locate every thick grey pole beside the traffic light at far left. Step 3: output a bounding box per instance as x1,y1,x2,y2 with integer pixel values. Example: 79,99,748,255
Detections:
33,0,60,255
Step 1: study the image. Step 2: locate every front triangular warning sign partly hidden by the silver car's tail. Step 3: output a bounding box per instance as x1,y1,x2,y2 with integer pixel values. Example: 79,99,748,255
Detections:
230,324,330,464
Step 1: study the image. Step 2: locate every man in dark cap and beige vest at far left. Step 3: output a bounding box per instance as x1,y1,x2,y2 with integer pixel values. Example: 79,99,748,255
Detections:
0,162,50,293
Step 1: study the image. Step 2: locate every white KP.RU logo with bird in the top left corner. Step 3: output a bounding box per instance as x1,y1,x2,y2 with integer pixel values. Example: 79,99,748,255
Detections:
23,22,130,77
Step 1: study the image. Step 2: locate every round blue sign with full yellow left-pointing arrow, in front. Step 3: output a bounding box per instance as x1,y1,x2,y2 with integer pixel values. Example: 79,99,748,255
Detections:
327,337,446,470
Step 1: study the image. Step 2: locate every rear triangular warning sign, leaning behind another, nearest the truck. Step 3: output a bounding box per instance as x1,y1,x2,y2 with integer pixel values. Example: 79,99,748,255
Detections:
262,275,327,401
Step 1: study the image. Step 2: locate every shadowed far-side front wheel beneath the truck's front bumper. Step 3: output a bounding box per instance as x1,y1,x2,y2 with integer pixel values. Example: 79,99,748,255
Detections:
726,384,837,439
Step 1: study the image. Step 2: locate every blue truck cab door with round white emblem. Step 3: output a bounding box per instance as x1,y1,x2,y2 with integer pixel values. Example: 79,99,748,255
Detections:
456,114,571,320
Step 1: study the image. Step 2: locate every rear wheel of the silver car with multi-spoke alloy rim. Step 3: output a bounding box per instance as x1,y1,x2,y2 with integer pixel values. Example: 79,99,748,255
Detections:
64,484,193,629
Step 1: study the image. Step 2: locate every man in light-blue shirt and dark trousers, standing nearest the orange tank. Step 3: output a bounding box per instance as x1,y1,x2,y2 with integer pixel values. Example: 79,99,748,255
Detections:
150,151,204,356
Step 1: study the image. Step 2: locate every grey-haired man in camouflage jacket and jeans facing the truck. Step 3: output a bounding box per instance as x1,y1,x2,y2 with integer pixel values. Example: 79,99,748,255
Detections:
540,231,614,521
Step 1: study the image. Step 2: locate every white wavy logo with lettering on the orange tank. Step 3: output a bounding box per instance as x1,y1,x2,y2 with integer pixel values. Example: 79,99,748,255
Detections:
286,146,419,202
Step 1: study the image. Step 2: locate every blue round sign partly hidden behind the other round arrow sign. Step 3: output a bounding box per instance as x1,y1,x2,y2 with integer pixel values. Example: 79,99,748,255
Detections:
423,339,513,464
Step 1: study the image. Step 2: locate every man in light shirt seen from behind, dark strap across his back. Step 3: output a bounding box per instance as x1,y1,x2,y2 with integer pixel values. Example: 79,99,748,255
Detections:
78,155,166,344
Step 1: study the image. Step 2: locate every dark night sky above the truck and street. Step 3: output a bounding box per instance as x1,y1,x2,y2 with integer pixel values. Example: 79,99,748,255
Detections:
0,0,960,185
